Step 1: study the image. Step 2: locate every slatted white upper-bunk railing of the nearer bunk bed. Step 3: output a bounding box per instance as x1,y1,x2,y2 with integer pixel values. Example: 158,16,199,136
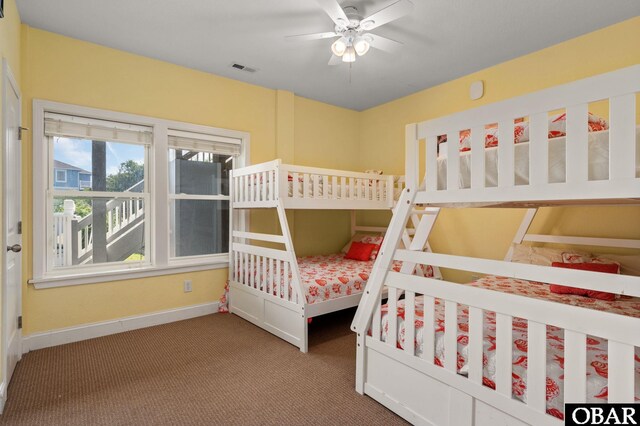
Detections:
405,65,640,205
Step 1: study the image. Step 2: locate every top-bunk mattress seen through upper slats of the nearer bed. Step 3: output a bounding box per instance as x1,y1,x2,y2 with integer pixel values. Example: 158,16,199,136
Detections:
438,126,640,190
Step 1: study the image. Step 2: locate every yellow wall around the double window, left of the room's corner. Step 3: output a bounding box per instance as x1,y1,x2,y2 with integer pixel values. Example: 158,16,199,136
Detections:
22,25,358,335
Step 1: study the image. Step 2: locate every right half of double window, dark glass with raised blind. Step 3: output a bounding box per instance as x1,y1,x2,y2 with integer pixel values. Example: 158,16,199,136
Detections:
169,132,240,258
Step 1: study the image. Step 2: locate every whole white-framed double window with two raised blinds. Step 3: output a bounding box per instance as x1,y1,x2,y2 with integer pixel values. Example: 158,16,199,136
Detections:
32,101,249,288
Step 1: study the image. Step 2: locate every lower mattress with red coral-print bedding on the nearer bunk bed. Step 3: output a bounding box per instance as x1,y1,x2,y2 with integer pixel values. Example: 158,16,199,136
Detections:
381,276,640,418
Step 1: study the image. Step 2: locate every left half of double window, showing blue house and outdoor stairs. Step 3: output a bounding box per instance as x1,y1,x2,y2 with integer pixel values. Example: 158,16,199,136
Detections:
45,114,151,269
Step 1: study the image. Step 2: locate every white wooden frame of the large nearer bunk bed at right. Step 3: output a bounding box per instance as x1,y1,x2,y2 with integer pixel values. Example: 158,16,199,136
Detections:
352,65,640,425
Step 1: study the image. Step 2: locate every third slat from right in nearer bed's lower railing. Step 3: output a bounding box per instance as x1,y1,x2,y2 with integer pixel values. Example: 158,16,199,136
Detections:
527,321,547,413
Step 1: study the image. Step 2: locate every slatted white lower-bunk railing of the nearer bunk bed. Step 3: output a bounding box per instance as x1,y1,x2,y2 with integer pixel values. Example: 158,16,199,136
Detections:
358,250,640,424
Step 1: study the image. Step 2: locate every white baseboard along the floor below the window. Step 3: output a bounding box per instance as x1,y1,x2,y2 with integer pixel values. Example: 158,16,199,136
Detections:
22,302,219,353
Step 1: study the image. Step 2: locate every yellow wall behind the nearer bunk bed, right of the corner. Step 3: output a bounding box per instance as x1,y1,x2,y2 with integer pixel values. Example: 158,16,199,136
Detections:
360,17,640,281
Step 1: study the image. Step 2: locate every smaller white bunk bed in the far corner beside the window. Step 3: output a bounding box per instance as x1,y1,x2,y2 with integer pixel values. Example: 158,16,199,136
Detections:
229,160,440,352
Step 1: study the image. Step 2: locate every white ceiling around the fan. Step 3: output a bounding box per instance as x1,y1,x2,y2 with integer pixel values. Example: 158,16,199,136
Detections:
17,0,640,110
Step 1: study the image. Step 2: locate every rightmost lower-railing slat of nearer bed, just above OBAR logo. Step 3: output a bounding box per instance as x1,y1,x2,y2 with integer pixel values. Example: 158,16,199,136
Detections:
608,340,635,403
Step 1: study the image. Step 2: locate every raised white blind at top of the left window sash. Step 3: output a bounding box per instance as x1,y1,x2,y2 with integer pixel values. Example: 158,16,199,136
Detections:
44,113,153,144
